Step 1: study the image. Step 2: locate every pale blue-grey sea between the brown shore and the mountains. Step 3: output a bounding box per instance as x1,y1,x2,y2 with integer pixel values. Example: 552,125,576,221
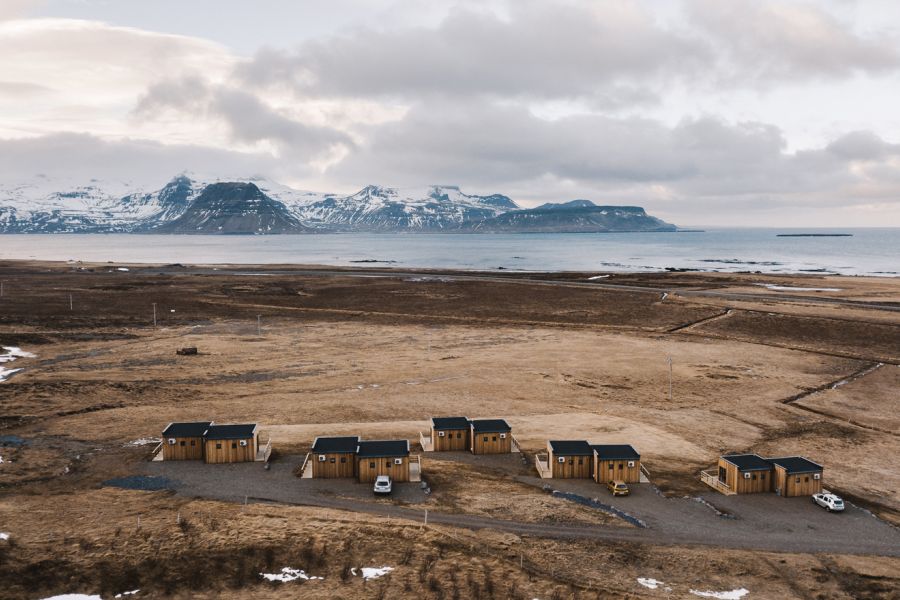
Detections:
0,228,900,276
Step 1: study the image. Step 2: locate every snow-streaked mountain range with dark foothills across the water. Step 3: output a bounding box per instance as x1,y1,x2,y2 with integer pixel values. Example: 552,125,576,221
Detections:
0,173,674,234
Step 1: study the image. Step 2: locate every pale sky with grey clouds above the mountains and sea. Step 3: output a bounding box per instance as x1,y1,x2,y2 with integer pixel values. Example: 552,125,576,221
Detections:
0,0,900,227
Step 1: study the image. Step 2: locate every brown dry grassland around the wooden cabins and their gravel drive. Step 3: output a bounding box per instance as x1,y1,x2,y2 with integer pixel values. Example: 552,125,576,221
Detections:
0,263,900,598
